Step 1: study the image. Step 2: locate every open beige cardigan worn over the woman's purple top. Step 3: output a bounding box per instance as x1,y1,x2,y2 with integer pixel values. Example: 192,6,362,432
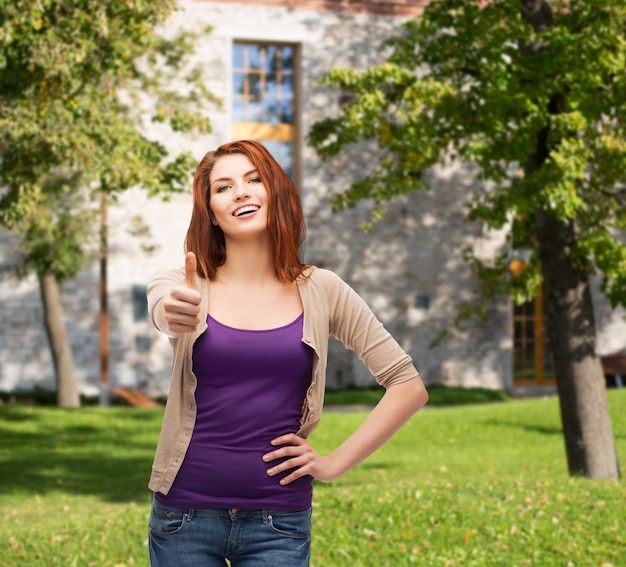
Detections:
148,267,418,494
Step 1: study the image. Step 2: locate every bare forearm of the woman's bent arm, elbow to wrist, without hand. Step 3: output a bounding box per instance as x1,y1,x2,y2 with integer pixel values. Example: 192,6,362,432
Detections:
330,377,428,478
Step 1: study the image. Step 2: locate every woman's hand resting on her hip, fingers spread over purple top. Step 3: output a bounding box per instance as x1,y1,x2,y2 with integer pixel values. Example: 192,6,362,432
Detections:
263,433,339,485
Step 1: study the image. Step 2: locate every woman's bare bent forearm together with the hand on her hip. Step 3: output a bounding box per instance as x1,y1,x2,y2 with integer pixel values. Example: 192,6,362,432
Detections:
263,376,428,484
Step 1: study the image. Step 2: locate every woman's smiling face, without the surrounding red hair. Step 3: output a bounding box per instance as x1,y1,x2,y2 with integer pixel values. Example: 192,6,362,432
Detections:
209,154,268,238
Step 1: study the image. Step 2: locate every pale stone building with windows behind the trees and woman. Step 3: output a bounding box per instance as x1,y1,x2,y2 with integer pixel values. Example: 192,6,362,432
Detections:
0,0,626,395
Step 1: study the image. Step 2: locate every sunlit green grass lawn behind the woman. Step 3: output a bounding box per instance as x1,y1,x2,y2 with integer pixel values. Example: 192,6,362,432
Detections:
0,390,626,567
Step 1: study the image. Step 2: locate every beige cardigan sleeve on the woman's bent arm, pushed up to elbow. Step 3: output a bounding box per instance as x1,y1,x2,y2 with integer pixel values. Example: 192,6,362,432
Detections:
322,270,419,388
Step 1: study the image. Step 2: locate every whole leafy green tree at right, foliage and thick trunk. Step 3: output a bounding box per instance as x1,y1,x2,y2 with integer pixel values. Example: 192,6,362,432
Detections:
310,0,626,478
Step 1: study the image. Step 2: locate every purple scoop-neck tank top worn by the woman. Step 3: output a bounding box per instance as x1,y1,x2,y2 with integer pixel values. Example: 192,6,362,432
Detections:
155,314,313,511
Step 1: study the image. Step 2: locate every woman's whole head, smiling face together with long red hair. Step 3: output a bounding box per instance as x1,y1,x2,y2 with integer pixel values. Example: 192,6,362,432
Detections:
185,140,306,283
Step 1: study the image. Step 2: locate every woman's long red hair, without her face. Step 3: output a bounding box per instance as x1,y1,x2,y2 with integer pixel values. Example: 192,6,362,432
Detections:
185,140,307,283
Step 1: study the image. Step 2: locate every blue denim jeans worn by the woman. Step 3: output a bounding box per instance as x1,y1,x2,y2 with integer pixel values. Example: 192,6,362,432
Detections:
149,500,311,567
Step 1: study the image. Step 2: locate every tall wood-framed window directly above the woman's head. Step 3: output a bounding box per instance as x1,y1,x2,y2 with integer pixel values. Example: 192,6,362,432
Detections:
232,42,297,181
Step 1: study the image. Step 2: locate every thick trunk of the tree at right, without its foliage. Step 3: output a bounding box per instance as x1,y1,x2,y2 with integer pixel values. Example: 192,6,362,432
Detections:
535,210,619,479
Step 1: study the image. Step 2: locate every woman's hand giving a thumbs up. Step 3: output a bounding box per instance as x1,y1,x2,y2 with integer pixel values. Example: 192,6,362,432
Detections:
163,252,202,337
